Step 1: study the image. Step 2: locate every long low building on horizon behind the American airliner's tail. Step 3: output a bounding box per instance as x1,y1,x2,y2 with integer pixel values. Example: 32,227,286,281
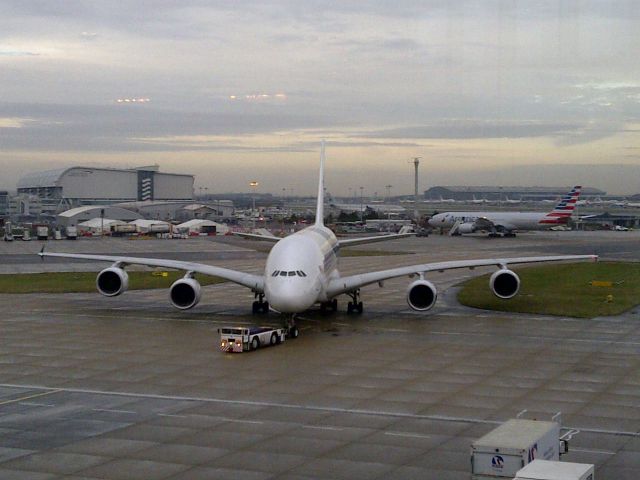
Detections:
424,186,607,202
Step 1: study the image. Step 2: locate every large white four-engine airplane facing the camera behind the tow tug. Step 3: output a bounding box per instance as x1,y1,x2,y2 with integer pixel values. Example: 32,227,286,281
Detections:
40,148,597,337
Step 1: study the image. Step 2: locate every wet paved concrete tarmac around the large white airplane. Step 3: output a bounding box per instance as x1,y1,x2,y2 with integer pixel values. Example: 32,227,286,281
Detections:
0,232,640,480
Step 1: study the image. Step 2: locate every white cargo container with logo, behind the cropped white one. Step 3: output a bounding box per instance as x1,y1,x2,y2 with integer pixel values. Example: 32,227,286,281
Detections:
471,419,560,480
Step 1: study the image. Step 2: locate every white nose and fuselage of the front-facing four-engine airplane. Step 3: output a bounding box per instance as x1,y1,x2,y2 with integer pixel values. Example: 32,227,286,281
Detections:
264,225,339,313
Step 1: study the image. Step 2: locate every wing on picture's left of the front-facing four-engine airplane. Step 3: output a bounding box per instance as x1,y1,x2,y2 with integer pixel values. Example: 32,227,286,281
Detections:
38,248,264,293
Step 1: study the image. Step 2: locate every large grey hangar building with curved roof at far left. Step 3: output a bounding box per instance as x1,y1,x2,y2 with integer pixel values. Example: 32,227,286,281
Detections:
17,165,194,213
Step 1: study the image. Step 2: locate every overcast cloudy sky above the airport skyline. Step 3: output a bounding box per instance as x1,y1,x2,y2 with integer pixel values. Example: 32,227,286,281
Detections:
0,0,640,195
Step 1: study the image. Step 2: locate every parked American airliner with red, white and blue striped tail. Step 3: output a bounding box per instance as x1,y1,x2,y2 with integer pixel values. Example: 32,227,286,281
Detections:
429,186,582,236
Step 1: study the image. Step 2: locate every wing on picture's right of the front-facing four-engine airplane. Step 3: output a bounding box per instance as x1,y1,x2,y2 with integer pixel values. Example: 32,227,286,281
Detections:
327,255,598,298
